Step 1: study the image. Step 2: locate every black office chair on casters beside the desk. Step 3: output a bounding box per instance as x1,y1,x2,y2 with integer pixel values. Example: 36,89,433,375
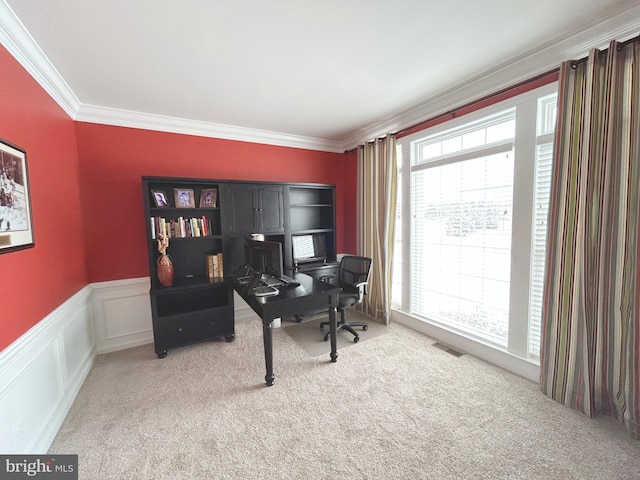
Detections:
320,255,371,342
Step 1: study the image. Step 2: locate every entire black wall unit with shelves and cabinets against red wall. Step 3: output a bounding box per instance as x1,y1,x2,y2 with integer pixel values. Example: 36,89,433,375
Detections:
142,176,337,358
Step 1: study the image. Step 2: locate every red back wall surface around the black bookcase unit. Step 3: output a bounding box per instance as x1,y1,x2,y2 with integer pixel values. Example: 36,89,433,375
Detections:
76,123,357,282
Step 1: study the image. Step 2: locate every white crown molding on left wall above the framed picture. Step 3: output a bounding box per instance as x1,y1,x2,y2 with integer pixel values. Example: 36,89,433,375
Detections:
0,0,80,118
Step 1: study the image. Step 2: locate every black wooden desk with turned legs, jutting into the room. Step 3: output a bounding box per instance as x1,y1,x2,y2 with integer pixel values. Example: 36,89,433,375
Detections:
235,273,342,386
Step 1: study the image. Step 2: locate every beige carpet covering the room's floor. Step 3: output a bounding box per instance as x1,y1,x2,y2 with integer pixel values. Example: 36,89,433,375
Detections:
50,321,640,480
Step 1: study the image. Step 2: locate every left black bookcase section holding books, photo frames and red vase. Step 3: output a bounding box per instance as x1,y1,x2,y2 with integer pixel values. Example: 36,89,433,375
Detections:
142,177,235,358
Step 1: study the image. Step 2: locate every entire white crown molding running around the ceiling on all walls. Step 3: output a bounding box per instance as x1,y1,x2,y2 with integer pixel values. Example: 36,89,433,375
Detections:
6,0,640,153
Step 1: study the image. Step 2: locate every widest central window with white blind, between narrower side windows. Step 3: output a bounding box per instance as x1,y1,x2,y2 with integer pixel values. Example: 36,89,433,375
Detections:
410,111,515,347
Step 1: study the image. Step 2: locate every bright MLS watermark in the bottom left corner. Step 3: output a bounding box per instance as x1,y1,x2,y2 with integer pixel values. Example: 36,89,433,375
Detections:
0,455,78,480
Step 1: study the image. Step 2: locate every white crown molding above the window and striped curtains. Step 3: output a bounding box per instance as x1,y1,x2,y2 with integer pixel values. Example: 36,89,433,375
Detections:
342,6,640,150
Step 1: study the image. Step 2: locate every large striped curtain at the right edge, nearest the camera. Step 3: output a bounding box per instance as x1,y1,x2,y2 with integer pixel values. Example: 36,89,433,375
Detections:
540,39,640,439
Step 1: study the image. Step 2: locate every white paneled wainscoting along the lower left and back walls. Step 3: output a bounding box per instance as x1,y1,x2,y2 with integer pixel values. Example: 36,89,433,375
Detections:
0,277,259,454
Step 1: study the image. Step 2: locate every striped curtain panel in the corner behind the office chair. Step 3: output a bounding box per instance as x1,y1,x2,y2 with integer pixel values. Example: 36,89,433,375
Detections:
356,135,398,325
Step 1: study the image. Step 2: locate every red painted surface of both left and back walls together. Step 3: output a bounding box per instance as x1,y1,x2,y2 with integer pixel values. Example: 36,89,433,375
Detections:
0,47,357,351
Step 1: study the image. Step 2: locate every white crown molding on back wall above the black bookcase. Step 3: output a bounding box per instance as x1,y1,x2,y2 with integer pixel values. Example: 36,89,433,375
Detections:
75,105,343,153
